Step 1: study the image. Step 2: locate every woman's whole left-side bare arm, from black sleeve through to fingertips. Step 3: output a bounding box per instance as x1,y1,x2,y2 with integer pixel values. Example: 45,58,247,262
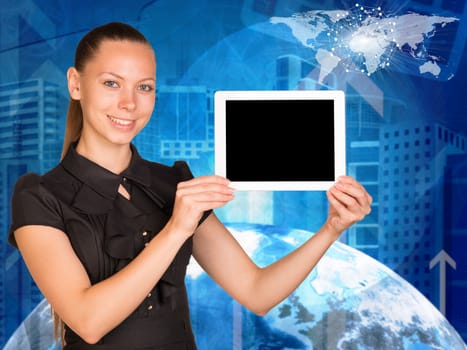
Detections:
15,176,233,343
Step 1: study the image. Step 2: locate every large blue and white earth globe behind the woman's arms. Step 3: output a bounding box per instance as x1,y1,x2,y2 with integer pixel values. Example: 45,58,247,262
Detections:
4,223,467,350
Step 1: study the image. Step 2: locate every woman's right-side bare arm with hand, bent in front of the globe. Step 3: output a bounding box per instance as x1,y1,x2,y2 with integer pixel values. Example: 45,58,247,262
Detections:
193,176,372,315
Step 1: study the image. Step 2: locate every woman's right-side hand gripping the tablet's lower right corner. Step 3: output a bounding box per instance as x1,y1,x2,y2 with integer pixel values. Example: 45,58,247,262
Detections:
326,176,373,239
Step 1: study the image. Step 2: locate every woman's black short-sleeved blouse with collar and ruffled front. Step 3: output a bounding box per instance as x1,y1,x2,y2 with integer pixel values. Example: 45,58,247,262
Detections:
8,145,211,350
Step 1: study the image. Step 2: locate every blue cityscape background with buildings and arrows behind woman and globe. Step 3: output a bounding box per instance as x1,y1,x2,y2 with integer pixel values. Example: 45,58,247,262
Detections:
0,0,467,345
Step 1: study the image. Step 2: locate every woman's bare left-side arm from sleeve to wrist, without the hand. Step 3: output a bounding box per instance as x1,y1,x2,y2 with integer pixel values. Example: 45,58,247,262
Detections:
15,226,188,343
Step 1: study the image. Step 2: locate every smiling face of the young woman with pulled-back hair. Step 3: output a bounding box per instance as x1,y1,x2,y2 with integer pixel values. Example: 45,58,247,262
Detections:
72,40,156,145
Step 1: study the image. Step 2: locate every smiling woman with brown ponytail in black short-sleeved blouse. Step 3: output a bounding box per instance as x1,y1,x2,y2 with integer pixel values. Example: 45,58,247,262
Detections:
9,23,372,350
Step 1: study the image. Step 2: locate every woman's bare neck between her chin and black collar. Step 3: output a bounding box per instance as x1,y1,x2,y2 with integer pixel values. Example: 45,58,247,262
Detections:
76,139,131,174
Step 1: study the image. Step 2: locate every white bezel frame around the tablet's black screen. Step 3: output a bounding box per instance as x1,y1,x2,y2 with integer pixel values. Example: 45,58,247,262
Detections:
214,90,346,191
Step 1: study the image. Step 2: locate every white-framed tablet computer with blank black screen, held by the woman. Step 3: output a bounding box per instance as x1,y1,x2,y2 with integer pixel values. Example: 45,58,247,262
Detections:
214,90,346,191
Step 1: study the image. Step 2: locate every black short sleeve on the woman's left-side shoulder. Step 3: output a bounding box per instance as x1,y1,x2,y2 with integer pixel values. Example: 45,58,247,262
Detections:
8,174,65,247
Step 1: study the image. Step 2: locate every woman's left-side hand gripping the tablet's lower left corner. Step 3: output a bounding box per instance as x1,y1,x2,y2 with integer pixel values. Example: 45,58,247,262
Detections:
170,175,234,235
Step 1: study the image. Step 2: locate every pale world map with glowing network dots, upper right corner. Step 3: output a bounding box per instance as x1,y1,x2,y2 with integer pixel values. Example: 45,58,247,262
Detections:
270,4,459,83
